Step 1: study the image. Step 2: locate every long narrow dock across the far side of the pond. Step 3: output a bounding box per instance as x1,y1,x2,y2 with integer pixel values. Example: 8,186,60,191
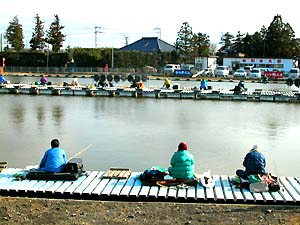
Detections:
0,84,300,103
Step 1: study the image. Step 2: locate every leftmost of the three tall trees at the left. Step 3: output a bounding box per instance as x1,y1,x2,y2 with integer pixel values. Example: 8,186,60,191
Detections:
5,16,24,51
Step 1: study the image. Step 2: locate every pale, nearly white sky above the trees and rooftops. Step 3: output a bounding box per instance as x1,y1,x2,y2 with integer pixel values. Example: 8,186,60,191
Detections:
0,0,300,48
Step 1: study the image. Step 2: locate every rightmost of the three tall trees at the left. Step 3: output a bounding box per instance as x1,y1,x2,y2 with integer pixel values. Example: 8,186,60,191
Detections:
46,15,66,52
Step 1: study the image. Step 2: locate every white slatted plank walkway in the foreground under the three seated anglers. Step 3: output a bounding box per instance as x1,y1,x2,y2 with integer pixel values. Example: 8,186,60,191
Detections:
0,168,300,205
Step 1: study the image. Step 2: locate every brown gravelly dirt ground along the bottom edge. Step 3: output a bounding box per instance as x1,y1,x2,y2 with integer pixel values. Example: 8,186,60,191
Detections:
0,197,300,225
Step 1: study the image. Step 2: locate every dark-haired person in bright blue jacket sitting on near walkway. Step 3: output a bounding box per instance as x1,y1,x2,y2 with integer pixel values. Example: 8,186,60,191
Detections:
38,139,67,173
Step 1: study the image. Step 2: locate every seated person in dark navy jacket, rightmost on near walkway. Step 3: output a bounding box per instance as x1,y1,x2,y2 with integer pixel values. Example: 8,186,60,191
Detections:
236,145,266,180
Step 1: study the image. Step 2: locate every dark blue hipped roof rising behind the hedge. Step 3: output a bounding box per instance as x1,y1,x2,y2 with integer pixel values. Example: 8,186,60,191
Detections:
120,37,176,53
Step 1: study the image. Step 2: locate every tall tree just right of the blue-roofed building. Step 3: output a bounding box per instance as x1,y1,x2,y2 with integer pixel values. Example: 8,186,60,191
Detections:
175,22,193,61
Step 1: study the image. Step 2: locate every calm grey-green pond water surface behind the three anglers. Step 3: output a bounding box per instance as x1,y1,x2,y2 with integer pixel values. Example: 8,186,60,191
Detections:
0,78,300,176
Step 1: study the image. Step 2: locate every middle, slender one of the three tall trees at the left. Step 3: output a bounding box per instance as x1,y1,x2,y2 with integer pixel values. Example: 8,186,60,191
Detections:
29,14,45,50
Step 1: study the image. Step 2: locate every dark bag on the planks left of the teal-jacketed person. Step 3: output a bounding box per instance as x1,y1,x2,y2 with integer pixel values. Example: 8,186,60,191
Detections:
140,166,167,186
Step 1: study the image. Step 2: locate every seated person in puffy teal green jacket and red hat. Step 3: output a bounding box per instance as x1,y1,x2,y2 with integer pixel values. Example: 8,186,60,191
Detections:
168,142,194,179
